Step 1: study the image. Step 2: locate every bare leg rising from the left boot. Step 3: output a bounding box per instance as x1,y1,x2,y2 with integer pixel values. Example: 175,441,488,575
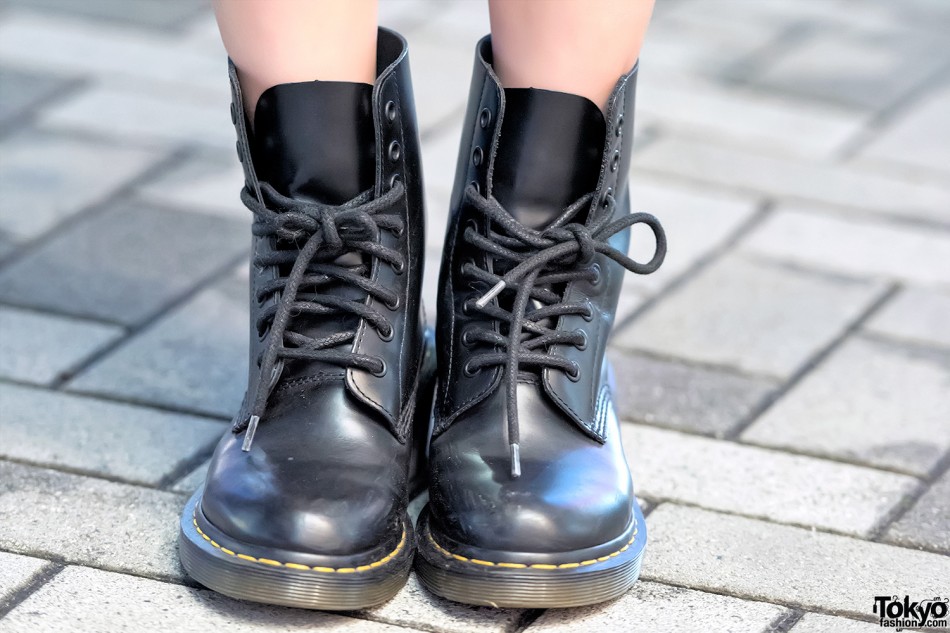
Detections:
214,0,377,122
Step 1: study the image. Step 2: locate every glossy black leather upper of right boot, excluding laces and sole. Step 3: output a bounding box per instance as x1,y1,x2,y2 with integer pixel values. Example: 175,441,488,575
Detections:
430,38,648,554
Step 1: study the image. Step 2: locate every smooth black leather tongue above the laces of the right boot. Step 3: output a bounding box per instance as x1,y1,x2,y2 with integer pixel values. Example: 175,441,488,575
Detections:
492,88,607,229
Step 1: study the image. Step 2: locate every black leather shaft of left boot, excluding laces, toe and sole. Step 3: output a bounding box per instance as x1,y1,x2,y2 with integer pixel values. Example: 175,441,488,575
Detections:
229,28,425,438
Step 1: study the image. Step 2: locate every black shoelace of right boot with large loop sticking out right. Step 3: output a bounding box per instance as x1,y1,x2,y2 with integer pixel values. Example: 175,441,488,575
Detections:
462,185,666,477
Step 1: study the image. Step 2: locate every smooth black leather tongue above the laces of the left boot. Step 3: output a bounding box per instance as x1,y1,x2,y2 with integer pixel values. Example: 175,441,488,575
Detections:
251,81,376,204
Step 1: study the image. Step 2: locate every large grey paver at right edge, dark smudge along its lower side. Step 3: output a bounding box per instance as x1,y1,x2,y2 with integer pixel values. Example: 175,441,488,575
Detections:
742,338,950,475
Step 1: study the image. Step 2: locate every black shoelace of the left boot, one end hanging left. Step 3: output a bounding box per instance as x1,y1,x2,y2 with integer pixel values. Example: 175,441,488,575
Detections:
233,182,406,451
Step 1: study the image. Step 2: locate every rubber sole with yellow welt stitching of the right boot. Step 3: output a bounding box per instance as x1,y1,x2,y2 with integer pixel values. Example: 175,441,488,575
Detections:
415,508,646,609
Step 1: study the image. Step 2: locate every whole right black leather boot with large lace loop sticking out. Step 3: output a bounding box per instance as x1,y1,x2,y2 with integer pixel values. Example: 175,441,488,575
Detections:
416,38,666,607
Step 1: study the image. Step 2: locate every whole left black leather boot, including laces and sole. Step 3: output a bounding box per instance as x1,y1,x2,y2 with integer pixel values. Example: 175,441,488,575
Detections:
180,29,434,609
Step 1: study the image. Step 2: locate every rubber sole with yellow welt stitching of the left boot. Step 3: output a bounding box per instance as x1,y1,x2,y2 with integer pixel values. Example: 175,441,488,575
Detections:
178,489,414,611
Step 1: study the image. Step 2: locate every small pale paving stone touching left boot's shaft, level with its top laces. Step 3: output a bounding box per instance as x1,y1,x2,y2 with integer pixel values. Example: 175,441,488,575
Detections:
138,151,252,225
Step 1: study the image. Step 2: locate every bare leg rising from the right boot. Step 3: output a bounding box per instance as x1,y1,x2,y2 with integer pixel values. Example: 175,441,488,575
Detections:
489,0,653,109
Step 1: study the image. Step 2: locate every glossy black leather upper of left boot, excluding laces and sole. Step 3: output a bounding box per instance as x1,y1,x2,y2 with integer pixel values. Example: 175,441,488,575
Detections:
206,29,427,556
